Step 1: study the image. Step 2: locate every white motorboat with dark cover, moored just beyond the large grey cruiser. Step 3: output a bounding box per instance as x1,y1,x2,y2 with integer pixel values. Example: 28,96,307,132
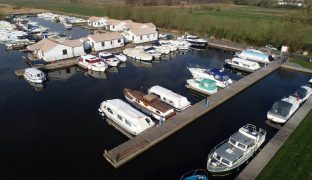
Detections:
267,95,300,124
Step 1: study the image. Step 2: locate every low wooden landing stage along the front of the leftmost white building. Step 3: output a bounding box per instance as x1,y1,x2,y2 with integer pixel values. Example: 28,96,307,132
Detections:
14,58,77,78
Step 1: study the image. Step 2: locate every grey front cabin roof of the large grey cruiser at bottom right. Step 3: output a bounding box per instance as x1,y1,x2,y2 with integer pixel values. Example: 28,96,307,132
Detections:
215,142,244,162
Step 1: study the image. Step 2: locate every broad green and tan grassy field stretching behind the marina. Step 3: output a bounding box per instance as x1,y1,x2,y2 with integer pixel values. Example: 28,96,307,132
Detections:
0,0,312,51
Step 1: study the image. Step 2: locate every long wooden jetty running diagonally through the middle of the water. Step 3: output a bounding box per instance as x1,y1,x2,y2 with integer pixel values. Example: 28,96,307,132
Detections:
103,62,280,168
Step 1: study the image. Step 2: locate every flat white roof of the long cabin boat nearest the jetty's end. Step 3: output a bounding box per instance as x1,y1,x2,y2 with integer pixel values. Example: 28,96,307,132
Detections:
106,99,148,125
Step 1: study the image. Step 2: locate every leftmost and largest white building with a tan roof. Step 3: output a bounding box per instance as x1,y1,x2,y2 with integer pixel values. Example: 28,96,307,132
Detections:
27,39,85,62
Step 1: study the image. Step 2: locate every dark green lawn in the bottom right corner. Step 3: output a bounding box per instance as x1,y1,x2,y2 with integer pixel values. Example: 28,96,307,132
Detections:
257,111,312,180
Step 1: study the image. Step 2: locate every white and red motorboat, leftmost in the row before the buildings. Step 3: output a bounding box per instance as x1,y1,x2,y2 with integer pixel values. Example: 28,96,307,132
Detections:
77,54,107,72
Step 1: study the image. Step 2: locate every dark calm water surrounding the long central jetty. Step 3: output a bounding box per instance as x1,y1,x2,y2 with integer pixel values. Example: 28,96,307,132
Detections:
0,18,309,180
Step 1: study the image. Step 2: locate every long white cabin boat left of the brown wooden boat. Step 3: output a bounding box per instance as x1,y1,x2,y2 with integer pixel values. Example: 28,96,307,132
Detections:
99,99,155,135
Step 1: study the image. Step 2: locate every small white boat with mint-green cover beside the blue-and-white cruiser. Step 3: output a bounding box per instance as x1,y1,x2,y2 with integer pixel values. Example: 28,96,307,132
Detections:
186,78,218,95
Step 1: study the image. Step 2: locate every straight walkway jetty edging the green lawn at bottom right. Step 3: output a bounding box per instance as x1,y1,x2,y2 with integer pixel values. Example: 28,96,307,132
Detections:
236,97,312,180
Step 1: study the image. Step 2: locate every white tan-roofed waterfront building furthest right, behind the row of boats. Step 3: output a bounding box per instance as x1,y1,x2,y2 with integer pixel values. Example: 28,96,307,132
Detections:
122,23,158,44
